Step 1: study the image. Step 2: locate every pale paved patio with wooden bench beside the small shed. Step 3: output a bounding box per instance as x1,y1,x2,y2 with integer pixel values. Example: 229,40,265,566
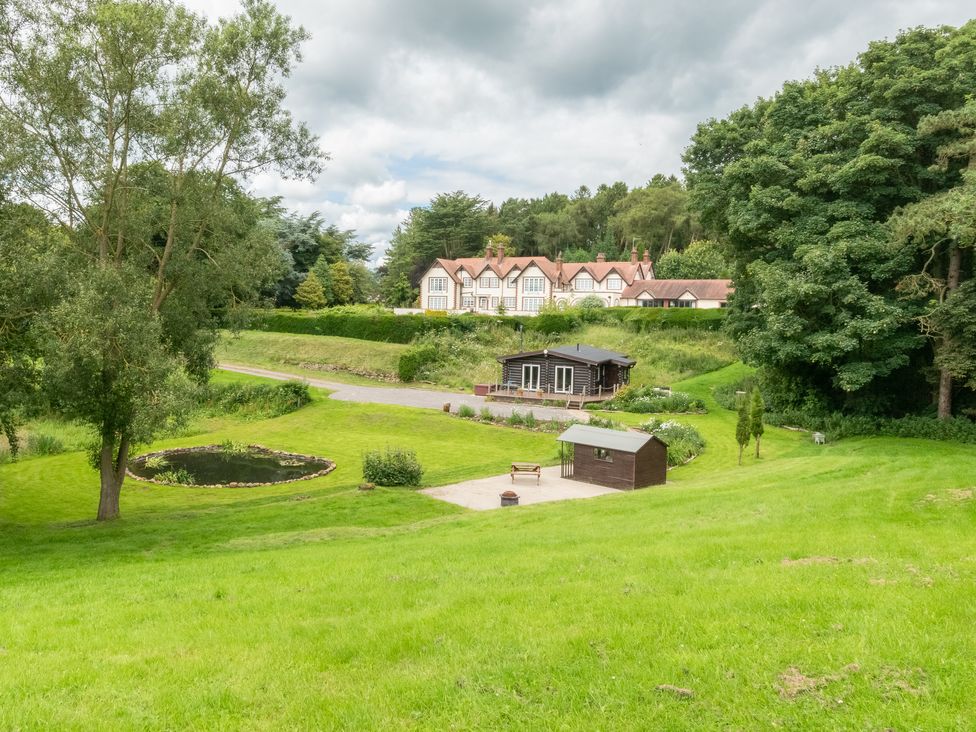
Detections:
421,465,619,511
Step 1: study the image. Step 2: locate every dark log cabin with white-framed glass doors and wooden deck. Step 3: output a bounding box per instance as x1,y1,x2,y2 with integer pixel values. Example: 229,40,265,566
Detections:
498,343,637,398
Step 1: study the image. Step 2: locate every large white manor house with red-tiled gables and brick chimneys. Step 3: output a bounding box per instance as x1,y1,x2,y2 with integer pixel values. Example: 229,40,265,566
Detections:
420,244,732,315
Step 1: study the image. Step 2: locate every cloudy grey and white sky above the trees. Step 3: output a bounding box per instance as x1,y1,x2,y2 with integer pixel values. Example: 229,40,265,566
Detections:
189,0,976,264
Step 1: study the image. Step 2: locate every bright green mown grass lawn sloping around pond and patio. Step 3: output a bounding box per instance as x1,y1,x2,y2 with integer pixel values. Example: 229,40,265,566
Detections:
0,366,976,730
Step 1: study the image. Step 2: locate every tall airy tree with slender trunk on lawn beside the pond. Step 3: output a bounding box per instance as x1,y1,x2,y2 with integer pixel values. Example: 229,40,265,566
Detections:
0,0,324,519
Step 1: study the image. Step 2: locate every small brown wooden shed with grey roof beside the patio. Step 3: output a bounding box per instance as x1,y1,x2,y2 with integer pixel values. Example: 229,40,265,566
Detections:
557,424,668,490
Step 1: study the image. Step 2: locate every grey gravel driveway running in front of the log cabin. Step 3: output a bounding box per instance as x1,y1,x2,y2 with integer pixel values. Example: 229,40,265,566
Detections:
219,363,590,422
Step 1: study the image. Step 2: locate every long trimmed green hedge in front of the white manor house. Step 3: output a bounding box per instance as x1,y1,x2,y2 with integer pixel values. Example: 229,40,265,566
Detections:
250,308,725,343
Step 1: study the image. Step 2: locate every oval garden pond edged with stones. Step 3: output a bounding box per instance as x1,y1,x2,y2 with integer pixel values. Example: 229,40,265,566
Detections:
128,443,335,488
